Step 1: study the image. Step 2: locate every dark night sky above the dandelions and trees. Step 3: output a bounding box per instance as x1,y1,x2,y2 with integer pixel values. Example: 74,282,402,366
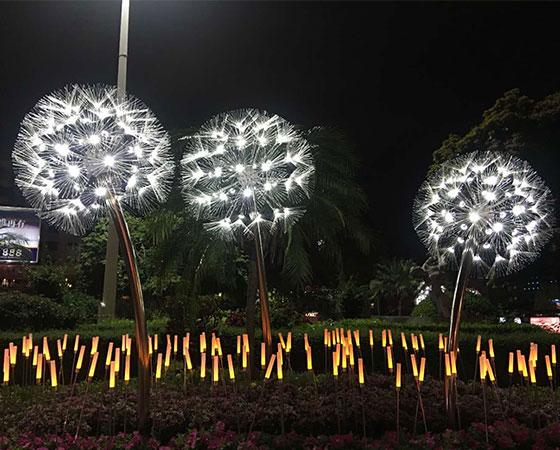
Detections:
0,0,560,258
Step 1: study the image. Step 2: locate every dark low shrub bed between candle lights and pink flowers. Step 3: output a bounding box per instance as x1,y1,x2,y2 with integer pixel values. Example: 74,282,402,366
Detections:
0,372,560,442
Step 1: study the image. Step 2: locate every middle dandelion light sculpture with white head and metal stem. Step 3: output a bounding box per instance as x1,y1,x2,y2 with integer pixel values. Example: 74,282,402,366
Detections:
181,109,314,348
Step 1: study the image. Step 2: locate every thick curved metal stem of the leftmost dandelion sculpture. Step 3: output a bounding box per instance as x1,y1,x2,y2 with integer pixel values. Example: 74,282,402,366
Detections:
107,189,151,432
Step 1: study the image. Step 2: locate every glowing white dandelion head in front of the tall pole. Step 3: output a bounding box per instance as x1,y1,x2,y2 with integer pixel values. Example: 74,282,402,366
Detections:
12,85,174,235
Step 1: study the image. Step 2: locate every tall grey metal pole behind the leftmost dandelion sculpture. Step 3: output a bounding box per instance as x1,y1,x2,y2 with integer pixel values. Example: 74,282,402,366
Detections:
99,0,130,317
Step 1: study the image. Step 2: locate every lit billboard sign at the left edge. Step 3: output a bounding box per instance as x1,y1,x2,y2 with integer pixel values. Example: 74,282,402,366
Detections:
0,206,41,263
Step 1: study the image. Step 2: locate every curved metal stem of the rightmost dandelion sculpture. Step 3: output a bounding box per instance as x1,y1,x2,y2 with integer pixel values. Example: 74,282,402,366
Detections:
446,250,473,428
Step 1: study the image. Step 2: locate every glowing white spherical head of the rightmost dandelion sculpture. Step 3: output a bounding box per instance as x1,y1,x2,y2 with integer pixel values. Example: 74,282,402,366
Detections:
413,152,555,277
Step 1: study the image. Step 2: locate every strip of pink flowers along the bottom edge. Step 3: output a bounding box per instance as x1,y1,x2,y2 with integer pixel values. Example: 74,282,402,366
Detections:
0,419,560,450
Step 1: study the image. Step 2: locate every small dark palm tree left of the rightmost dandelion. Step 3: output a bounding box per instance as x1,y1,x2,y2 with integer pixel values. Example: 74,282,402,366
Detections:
369,258,419,316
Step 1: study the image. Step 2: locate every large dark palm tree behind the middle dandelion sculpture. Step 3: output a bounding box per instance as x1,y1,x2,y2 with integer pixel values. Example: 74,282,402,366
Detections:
241,127,373,346
